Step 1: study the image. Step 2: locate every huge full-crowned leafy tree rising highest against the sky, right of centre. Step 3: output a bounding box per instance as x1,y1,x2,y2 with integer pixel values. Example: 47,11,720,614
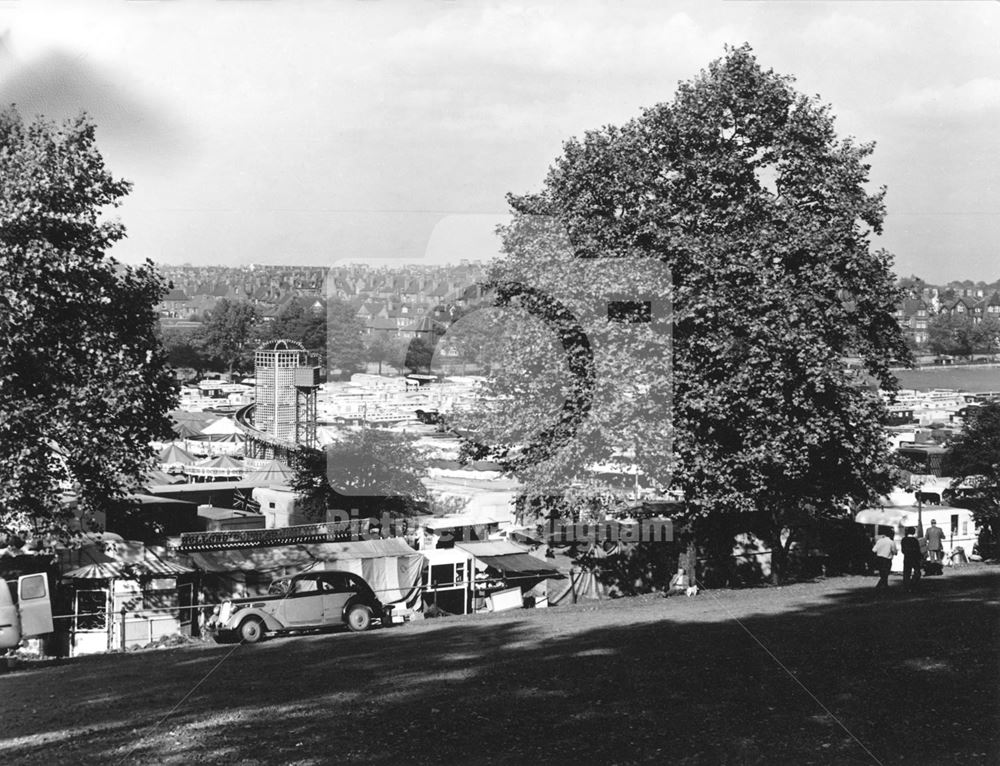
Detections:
458,46,909,578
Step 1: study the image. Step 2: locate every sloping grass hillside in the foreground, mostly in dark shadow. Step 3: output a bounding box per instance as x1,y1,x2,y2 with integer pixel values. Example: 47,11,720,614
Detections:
0,567,1000,764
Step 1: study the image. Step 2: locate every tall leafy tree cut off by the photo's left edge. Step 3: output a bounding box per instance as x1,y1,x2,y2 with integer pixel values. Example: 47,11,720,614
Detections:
0,108,176,536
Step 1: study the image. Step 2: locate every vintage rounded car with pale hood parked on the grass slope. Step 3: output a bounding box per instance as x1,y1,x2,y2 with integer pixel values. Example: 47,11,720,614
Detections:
209,571,392,644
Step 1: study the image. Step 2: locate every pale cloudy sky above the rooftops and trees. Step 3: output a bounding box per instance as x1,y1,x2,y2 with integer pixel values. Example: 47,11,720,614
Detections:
0,0,1000,282
